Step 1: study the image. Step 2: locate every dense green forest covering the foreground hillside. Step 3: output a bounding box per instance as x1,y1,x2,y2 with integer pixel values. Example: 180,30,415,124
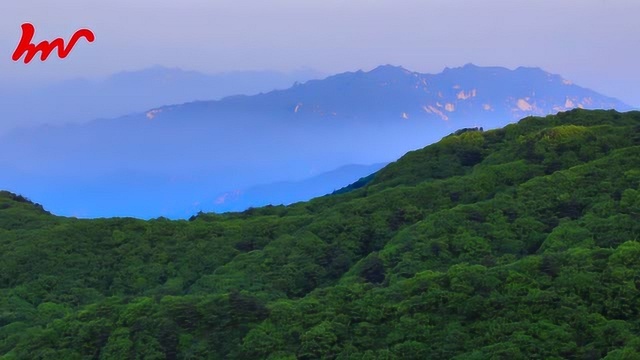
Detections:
0,109,640,360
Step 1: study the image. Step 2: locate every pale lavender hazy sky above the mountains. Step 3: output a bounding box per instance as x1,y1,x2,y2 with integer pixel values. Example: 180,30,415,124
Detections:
0,0,640,106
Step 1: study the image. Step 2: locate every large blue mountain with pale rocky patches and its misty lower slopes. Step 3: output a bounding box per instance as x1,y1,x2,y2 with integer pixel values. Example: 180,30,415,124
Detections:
0,65,629,217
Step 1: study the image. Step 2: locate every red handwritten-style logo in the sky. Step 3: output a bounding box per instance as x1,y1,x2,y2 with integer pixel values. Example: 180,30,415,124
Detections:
12,23,96,64
